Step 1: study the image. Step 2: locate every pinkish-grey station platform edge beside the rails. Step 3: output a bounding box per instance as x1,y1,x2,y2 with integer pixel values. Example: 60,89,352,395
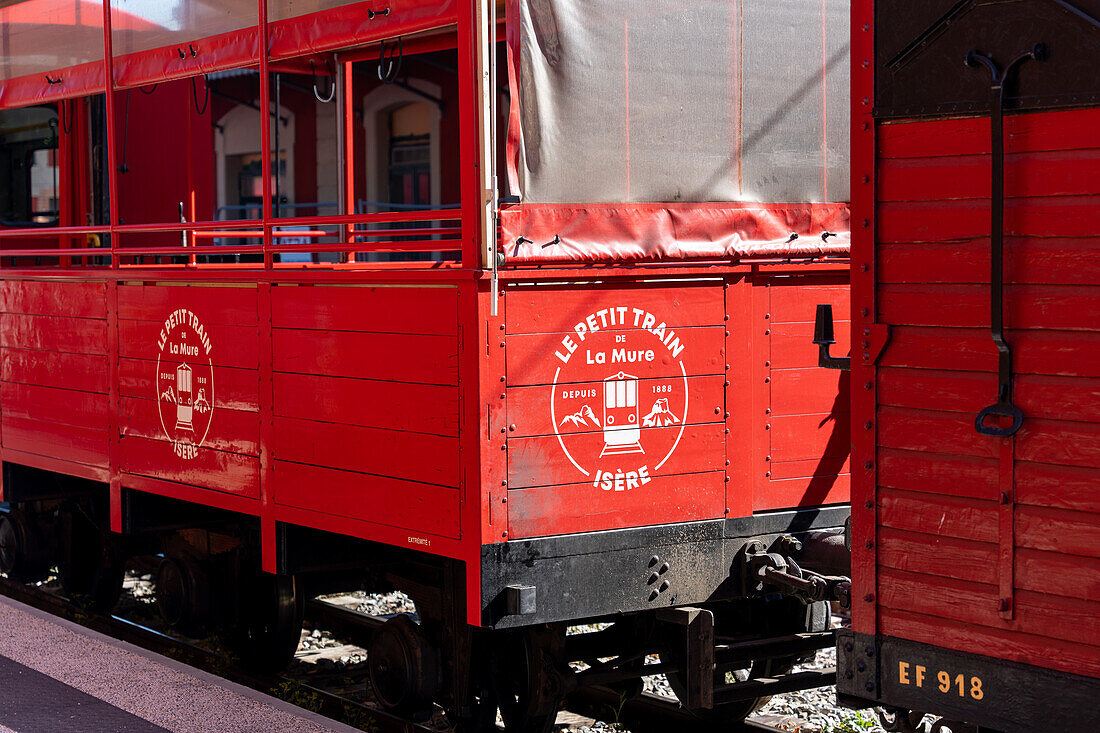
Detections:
0,597,356,733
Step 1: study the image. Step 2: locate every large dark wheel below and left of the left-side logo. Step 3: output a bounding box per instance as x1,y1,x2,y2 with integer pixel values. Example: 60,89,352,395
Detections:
57,502,124,613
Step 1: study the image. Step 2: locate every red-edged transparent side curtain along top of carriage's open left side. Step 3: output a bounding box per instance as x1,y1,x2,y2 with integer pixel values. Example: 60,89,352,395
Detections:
0,0,457,104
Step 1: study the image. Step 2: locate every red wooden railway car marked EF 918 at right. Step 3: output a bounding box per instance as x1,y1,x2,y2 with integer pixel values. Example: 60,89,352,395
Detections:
838,0,1100,731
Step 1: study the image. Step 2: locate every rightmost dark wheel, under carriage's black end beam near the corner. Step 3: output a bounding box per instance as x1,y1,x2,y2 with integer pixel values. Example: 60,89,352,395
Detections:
460,628,563,733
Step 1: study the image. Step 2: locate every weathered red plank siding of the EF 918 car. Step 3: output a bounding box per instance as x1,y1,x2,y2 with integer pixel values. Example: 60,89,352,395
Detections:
859,110,1100,676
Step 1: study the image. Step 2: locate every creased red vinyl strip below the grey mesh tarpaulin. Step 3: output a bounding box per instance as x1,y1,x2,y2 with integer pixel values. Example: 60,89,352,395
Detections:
501,204,850,262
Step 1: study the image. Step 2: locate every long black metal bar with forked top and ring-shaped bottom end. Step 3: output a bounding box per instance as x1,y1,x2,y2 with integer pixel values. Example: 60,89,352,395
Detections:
965,43,1047,438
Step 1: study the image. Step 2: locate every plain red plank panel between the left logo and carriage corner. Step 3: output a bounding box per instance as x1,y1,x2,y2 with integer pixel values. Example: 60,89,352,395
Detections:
272,285,461,538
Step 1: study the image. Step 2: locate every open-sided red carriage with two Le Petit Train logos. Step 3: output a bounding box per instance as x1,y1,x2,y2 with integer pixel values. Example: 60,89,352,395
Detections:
0,0,849,731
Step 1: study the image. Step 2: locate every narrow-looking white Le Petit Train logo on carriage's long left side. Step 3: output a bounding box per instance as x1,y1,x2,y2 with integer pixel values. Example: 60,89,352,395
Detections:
156,308,213,460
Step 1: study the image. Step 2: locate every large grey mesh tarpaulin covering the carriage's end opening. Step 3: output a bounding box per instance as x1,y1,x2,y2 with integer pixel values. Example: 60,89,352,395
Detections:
509,0,849,204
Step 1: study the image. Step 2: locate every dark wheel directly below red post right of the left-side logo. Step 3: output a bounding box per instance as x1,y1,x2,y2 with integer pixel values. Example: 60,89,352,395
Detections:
235,572,304,671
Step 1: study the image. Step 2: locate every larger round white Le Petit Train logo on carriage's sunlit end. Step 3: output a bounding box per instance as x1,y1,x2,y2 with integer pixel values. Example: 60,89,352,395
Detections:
550,306,688,491
